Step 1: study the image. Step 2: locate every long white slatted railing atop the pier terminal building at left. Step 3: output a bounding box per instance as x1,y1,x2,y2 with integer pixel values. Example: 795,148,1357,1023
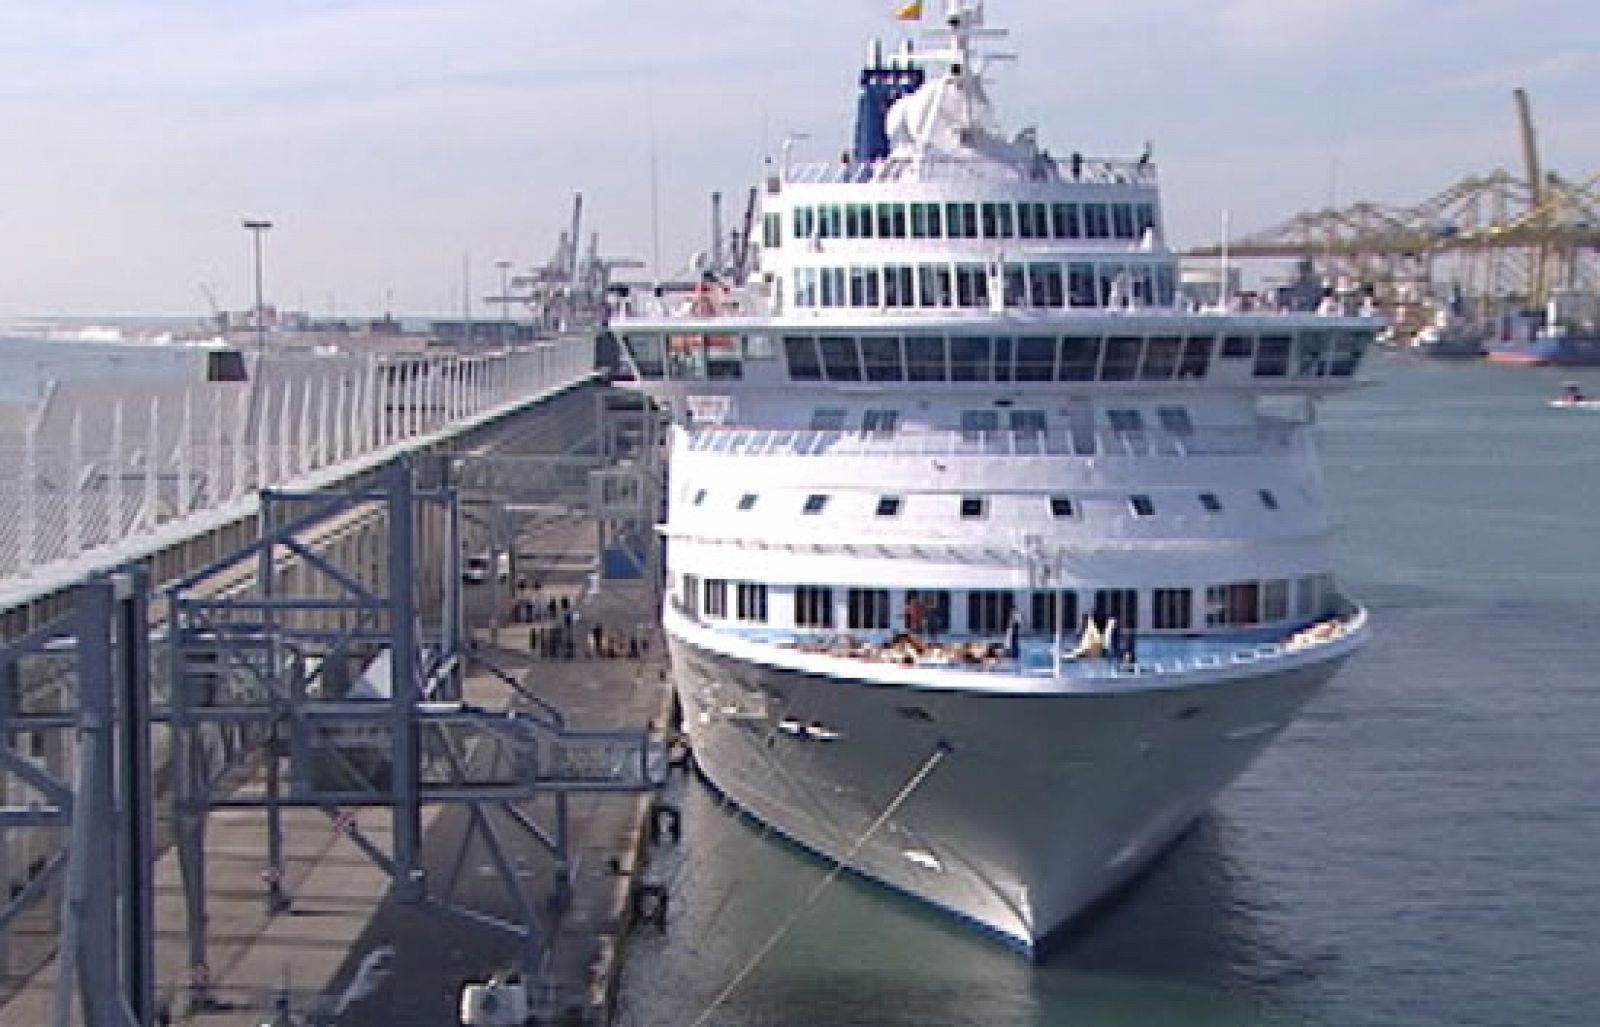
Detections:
0,338,595,588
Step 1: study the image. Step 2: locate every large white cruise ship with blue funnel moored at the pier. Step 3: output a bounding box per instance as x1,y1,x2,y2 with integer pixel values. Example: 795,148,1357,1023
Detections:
611,0,1378,953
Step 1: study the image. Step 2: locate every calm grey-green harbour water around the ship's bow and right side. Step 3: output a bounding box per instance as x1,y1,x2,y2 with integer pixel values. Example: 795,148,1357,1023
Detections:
621,357,1600,1027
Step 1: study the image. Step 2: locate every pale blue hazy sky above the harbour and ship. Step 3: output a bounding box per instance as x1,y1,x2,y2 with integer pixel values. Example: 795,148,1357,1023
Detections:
0,0,1600,318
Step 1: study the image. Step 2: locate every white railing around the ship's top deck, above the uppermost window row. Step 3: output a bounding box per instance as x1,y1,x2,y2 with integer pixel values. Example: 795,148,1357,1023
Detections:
782,154,1157,186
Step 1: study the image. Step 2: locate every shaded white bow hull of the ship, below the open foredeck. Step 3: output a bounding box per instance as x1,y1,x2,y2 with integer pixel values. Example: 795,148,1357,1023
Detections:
669,607,1349,953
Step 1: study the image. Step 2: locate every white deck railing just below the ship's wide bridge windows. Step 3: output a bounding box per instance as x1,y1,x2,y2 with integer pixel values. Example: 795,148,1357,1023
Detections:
686,426,1290,458
